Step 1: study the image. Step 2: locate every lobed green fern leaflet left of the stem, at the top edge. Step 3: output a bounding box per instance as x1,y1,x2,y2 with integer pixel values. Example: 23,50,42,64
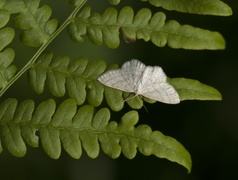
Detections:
3,0,58,47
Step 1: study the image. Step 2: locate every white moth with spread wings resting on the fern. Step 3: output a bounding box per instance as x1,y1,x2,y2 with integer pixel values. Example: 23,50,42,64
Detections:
98,59,180,104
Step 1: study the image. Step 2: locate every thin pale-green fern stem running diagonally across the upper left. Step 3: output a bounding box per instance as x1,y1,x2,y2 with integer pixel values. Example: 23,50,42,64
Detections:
0,0,87,97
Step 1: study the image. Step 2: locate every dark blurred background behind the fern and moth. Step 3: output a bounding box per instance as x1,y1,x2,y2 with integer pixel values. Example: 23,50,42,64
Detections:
0,0,238,180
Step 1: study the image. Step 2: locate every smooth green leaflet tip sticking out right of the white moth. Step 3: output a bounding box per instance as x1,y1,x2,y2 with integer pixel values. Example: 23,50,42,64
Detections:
167,78,222,101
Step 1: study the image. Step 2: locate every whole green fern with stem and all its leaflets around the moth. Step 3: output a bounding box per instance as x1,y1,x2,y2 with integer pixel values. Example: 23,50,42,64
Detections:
0,0,232,172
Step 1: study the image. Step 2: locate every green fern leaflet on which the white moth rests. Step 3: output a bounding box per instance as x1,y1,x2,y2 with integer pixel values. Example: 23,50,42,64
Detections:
28,53,221,111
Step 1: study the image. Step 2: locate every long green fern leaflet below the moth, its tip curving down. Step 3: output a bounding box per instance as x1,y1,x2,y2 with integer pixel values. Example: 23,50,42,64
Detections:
0,99,191,171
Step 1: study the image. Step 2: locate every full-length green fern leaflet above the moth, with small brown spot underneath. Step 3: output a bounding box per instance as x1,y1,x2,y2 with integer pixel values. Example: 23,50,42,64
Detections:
69,7,225,49
